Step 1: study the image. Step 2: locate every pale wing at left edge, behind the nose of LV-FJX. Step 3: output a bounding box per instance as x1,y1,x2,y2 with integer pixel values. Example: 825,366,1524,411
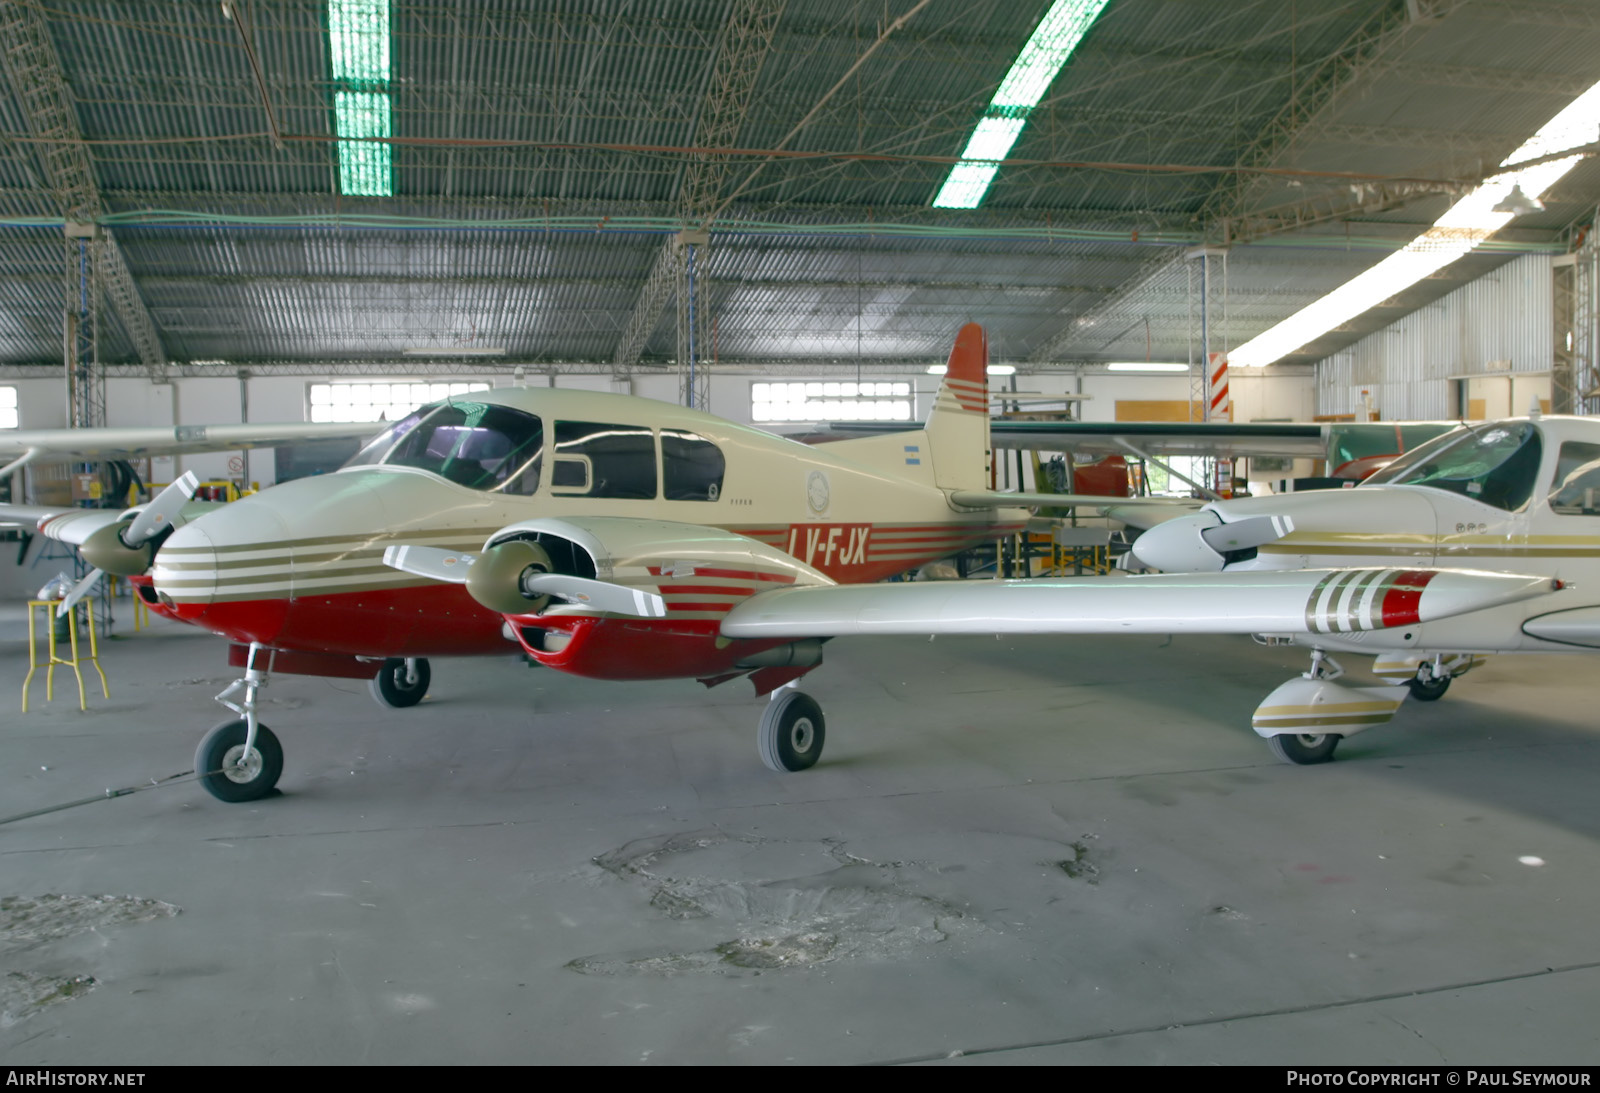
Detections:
0,421,376,462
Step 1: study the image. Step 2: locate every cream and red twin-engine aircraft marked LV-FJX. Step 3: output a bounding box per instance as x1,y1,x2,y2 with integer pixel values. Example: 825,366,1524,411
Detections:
15,323,1552,802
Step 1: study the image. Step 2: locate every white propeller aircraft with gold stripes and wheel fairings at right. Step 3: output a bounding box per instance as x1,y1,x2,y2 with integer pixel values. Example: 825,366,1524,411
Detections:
1133,418,1600,763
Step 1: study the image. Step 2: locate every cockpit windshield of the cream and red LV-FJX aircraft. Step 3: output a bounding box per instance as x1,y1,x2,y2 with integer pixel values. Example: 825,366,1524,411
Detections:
344,400,544,494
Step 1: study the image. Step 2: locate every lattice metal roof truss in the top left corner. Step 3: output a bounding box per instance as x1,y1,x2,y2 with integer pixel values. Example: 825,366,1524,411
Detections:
0,0,166,376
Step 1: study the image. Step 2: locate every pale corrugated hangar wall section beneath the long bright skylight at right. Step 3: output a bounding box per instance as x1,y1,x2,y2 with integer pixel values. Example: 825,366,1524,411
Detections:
1317,254,1555,421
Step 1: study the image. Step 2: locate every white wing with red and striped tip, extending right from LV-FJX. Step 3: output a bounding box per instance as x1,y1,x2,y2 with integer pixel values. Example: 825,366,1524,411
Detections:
722,568,1560,639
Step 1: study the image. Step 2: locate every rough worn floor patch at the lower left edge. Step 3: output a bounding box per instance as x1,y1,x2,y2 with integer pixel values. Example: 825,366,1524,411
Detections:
0,893,178,1029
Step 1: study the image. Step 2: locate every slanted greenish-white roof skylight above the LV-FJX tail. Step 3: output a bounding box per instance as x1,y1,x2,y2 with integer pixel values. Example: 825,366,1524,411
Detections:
933,0,1109,208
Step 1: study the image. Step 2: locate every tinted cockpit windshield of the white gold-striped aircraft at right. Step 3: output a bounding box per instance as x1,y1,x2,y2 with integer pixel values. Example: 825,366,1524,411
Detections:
1363,421,1544,512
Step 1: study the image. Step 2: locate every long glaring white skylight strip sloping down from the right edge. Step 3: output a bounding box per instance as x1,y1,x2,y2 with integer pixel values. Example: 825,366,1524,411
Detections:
1229,83,1600,368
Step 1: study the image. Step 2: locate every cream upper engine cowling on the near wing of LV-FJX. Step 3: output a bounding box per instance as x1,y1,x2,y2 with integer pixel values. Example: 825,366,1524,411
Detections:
467,517,834,615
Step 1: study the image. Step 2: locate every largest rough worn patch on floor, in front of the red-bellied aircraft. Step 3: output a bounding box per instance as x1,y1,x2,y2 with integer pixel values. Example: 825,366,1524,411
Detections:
566,831,984,975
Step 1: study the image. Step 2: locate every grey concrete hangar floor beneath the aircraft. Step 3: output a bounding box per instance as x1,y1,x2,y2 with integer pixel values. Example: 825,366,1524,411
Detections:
0,608,1600,1066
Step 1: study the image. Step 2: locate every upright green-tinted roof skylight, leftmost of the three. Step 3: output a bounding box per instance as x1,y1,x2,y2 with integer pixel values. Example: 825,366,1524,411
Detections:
328,0,394,197
